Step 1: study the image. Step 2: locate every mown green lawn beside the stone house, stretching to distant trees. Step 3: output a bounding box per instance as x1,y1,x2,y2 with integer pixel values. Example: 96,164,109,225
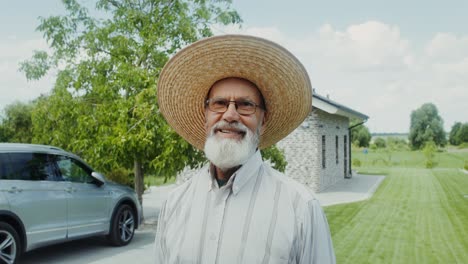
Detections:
325,151,468,263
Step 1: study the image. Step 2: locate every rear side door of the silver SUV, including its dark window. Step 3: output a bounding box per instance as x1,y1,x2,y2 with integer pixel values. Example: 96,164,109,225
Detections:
0,153,68,249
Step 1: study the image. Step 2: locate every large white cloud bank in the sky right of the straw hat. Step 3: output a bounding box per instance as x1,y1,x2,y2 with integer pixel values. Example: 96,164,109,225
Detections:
215,21,468,132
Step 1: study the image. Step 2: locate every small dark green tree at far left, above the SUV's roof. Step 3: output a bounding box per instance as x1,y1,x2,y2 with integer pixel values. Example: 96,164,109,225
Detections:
0,102,33,143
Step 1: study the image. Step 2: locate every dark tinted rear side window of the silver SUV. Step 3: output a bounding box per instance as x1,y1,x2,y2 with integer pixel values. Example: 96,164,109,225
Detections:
0,153,57,181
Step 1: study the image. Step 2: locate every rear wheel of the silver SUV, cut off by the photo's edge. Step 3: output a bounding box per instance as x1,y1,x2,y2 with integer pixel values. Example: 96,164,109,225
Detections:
0,222,21,264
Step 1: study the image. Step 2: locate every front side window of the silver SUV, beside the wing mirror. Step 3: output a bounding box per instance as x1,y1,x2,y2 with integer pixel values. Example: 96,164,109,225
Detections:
56,156,94,183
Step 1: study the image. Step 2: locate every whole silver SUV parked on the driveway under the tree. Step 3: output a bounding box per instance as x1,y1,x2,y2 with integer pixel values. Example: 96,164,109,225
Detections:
0,143,141,263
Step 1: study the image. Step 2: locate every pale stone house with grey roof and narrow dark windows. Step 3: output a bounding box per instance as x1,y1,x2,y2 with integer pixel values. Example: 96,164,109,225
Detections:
277,93,369,192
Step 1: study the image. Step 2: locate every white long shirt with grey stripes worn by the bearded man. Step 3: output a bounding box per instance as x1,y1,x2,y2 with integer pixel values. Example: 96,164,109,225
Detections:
155,151,335,264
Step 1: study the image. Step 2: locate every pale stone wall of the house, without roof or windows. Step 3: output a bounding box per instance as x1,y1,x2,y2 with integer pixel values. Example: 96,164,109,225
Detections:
277,108,349,192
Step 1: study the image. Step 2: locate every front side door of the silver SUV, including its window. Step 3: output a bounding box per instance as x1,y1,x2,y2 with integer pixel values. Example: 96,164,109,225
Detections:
56,156,111,238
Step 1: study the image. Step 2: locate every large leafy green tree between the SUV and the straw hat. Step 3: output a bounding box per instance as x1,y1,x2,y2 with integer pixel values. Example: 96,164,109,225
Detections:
20,0,241,206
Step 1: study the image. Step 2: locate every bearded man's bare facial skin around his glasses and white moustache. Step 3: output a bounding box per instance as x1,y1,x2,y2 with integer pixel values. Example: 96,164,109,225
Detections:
205,78,265,140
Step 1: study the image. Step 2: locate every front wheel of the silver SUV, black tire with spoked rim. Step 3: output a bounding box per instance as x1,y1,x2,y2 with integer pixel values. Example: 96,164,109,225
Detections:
108,204,136,247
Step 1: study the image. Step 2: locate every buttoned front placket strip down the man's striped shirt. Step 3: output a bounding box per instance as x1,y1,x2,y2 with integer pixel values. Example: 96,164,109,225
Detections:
203,186,231,263
